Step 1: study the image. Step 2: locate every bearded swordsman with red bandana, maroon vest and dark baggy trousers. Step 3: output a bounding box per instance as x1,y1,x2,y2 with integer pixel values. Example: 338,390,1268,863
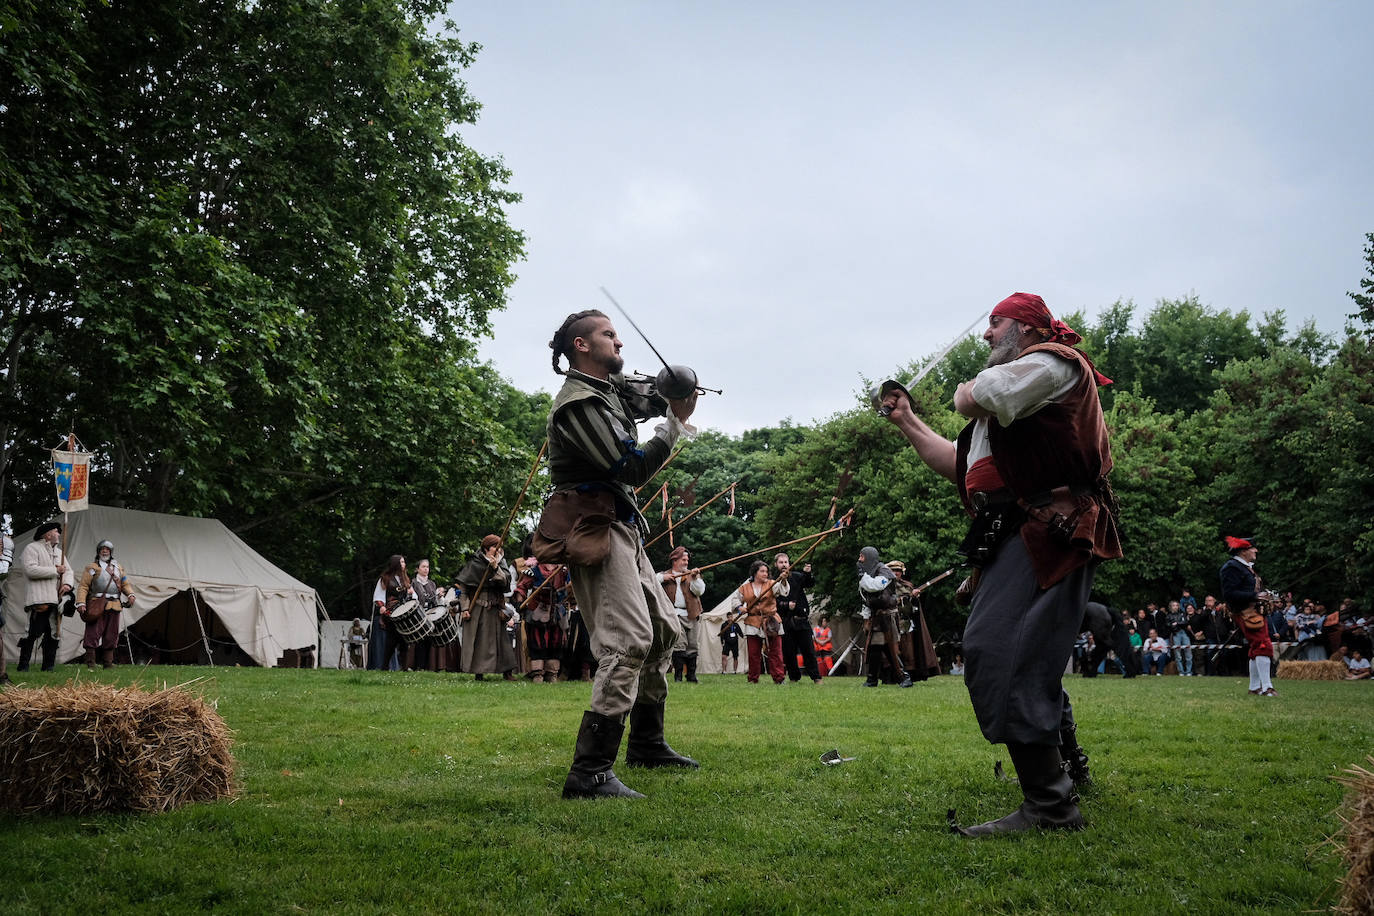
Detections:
882,293,1121,836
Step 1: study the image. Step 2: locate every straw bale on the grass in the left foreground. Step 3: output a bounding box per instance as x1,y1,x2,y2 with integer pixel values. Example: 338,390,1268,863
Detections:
0,684,236,814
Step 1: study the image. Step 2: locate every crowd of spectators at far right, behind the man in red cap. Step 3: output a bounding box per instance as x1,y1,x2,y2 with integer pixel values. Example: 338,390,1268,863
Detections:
1074,588,1374,680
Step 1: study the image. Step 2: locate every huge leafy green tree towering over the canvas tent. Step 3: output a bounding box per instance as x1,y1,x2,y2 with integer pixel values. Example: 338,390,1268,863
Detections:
0,0,527,615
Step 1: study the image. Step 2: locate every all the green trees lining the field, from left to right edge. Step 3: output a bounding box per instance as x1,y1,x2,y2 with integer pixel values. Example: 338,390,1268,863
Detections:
0,0,1374,632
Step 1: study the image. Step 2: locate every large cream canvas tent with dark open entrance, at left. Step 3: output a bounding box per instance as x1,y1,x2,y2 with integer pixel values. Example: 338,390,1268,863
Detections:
4,505,319,667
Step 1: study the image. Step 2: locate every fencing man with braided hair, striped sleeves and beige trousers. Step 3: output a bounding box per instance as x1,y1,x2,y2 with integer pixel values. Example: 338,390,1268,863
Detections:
533,310,697,798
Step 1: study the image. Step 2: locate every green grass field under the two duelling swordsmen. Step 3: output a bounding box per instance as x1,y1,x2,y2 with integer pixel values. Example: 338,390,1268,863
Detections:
0,667,1374,916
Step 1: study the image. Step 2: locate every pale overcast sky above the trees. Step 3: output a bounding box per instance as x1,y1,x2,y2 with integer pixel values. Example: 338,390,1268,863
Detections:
451,0,1374,434
